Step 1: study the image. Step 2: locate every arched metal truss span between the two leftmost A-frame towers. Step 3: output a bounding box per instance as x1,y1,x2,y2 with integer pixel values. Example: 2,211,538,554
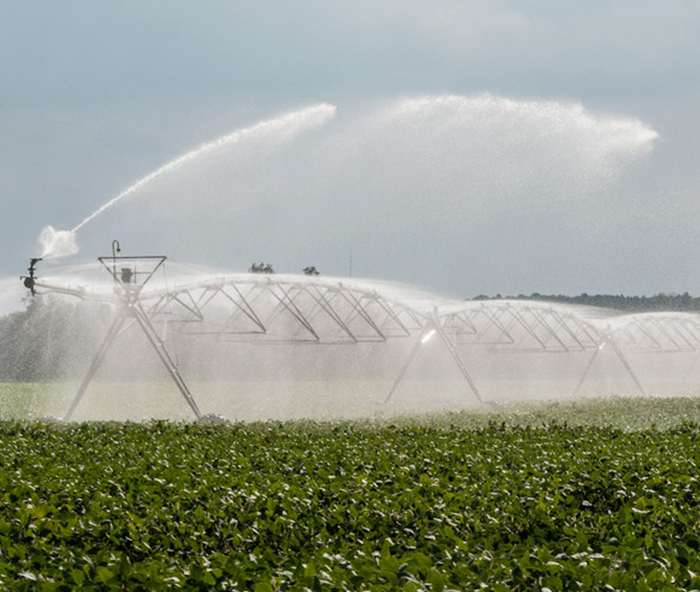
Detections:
147,274,425,344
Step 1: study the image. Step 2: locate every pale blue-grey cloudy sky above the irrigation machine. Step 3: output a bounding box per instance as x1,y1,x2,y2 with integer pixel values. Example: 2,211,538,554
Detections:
0,0,700,306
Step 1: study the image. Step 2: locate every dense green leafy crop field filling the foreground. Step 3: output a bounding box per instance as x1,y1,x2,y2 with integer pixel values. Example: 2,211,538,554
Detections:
0,398,700,592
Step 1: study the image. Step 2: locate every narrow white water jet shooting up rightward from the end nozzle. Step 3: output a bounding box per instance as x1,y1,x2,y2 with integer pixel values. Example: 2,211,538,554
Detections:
39,103,336,258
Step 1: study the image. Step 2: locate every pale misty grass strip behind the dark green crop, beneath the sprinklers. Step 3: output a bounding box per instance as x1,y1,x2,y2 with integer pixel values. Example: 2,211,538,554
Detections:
0,380,700,429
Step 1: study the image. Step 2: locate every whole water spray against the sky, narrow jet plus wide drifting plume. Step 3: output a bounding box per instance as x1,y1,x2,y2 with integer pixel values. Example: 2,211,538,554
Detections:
34,94,658,290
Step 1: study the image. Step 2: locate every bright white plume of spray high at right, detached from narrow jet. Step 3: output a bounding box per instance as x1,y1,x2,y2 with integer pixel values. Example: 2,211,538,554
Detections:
360,94,658,197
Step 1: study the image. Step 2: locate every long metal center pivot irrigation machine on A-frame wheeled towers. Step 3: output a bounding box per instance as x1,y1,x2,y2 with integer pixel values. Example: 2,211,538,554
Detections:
21,241,700,421
